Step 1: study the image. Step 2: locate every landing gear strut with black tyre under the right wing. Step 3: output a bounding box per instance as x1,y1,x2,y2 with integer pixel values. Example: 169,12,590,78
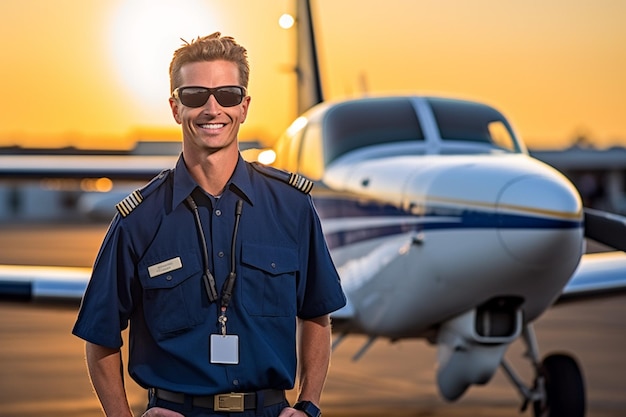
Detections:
501,324,586,417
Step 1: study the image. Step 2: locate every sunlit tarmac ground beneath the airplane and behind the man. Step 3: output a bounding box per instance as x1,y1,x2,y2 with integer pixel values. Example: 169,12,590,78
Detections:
0,225,626,417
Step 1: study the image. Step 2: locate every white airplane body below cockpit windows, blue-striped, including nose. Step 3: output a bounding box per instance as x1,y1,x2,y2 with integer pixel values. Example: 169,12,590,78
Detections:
314,150,583,338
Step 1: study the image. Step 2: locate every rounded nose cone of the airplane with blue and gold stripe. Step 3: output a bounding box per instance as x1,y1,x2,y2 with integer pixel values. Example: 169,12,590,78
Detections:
496,175,583,265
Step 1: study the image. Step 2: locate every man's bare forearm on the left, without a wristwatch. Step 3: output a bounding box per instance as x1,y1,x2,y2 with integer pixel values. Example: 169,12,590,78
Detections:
85,342,133,417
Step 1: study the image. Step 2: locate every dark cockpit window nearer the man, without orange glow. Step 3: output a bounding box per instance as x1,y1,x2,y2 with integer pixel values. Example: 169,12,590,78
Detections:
324,98,424,164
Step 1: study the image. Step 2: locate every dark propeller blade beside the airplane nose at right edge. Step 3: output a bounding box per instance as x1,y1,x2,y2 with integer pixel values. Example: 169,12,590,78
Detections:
584,208,626,252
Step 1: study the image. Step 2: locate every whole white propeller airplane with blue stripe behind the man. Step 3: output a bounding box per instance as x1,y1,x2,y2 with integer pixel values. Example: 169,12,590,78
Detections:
0,0,626,417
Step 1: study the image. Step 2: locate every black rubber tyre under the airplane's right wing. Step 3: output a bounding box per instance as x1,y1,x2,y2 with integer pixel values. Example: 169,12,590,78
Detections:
533,354,586,417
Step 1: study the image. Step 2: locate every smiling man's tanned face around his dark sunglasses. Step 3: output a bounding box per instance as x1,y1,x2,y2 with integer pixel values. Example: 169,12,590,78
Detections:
170,60,250,158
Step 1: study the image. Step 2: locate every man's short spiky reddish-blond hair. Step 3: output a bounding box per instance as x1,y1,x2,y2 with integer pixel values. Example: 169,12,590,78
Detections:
170,32,250,93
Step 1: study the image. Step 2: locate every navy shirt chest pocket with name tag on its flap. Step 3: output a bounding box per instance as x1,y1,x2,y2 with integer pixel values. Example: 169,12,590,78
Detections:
138,256,205,340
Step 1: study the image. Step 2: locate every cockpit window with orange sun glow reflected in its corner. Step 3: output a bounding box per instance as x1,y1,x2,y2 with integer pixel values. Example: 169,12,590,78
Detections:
427,98,519,151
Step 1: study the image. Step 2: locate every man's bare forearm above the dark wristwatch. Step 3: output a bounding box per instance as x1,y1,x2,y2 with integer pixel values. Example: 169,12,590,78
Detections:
298,315,331,405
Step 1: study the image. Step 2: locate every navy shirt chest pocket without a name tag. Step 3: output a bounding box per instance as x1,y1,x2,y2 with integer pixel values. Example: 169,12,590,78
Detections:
241,243,298,317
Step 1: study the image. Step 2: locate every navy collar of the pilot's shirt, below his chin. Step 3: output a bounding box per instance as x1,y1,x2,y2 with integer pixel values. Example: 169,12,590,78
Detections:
172,154,254,208
